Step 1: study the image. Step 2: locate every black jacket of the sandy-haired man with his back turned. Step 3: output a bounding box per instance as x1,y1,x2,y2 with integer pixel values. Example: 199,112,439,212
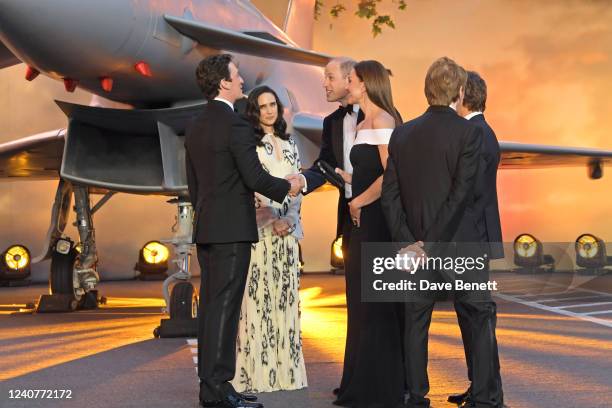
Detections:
381,106,483,251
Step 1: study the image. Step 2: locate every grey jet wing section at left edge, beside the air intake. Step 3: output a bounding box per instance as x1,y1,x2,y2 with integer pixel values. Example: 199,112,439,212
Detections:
0,129,66,180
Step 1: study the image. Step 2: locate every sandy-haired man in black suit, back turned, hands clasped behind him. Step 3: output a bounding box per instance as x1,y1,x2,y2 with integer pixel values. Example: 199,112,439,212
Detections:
381,57,500,407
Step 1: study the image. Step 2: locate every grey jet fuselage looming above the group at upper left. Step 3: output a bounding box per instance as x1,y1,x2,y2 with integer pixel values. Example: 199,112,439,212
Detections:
0,0,330,113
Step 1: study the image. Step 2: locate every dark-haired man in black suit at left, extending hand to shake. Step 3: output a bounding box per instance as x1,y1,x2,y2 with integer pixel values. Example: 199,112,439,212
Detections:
185,54,299,408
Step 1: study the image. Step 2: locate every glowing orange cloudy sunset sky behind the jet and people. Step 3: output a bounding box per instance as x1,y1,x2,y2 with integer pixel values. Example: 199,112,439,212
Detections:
0,0,612,277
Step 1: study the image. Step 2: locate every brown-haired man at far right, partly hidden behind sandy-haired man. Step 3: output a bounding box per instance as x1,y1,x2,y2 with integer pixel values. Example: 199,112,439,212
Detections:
448,71,504,405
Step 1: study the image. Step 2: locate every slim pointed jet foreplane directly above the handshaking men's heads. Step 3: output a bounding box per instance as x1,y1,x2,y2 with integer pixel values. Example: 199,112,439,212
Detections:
164,15,332,66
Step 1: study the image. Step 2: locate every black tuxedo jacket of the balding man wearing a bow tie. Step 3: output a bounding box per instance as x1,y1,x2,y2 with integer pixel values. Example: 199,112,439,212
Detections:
302,108,363,236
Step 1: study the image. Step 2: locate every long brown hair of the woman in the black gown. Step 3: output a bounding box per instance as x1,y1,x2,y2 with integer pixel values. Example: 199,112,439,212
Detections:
355,60,402,126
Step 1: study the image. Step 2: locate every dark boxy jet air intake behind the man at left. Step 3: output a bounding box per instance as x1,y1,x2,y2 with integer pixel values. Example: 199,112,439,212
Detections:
57,101,202,195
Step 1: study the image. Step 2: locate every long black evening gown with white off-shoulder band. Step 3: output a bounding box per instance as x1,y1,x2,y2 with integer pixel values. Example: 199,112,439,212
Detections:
334,129,405,408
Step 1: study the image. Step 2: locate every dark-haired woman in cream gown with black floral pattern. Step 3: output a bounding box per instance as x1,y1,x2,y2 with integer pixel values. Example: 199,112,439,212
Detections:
229,86,307,392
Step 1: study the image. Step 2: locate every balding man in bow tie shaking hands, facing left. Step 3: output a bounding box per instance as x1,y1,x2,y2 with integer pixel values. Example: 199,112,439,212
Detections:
286,58,363,395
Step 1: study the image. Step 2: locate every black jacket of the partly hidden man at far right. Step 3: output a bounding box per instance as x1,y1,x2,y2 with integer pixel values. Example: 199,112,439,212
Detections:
470,114,504,259
